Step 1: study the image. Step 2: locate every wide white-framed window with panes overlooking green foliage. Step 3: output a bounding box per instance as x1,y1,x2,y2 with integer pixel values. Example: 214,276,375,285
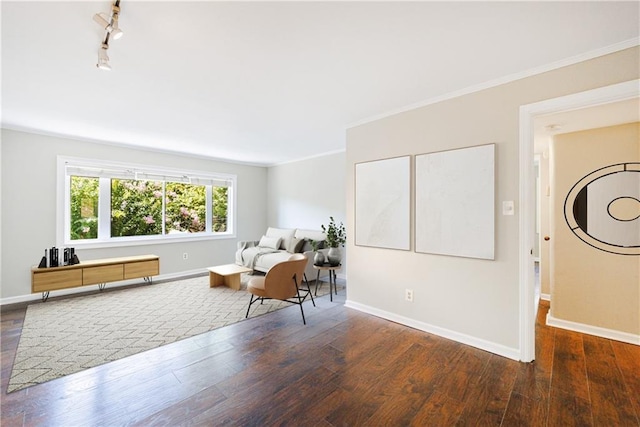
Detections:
58,157,236,246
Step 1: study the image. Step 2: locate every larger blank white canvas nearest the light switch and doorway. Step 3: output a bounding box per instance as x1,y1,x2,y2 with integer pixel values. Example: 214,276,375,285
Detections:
415,144,495,259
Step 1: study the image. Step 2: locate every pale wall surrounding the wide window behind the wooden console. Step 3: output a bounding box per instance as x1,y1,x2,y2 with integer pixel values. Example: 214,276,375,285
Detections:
0,129,267,303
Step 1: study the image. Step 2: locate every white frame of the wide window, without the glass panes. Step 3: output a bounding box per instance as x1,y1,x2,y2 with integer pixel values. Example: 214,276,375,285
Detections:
56,156,237,249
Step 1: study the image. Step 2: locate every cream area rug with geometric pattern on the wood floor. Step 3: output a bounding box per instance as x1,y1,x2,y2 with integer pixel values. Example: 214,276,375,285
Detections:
7,275,336,393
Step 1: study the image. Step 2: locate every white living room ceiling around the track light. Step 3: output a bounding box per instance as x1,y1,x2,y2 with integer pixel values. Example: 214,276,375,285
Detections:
1,0,640,165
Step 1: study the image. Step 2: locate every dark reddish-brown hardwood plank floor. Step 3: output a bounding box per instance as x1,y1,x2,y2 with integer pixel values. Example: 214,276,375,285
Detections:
1,284,640,427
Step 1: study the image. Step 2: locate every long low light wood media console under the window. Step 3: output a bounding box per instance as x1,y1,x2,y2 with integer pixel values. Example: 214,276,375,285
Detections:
31,255,160,301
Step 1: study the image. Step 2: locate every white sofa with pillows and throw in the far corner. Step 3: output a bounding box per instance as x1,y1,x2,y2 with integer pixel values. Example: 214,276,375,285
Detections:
236,227,329,280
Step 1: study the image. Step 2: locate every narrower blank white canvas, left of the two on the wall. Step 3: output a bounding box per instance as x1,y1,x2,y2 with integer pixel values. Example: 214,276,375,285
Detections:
355,156,411,250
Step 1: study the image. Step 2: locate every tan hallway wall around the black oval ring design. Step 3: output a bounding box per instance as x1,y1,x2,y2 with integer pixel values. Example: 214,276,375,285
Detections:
550,123,640,335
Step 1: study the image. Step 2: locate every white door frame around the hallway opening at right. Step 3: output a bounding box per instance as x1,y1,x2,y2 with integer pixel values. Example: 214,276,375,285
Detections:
518,80,640,362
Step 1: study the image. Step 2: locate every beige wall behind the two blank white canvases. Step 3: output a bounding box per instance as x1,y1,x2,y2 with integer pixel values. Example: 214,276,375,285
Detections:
346,47,640,357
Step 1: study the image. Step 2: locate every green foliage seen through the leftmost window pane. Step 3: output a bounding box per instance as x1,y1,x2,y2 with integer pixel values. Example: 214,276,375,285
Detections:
71,176,99,240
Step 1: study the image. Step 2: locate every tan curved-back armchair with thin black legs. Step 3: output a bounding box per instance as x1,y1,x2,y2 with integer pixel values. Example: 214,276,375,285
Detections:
245,254,316,325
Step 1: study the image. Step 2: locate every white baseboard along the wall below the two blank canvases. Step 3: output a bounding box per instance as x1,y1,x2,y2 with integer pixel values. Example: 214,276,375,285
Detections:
345,299,521,360
